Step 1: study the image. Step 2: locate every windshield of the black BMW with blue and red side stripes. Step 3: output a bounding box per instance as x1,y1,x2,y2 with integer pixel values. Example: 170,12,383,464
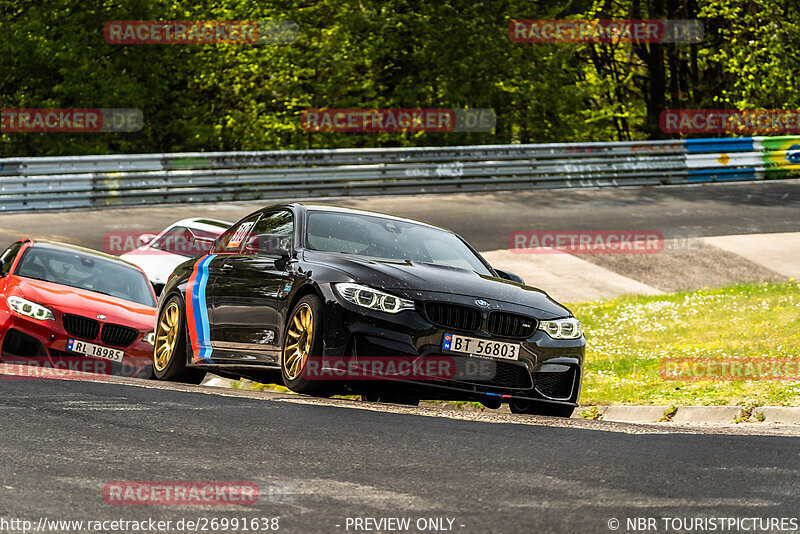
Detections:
306,211,491,276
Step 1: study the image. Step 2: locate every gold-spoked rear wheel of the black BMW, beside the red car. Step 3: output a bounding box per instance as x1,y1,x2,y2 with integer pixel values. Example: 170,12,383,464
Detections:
153,295,206,384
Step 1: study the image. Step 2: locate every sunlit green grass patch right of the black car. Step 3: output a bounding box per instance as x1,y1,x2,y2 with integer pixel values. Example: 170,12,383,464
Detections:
570,279,800,406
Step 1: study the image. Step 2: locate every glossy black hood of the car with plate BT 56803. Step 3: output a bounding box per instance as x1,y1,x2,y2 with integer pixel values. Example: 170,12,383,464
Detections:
304,252,571,317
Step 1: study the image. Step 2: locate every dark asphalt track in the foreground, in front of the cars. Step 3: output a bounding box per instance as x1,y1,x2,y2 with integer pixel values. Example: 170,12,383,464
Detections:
0,377,800,533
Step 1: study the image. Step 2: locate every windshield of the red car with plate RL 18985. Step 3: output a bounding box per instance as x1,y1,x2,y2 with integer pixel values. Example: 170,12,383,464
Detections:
14,247,156,307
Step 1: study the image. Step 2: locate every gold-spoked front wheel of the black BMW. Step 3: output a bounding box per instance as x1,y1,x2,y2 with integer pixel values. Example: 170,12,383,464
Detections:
280,295,332,396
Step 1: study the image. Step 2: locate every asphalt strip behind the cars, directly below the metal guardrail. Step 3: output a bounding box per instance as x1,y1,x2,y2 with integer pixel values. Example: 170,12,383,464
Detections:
0,180,800,251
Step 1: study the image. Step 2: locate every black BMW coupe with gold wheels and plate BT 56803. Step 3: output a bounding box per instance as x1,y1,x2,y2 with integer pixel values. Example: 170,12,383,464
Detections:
154,203,585,416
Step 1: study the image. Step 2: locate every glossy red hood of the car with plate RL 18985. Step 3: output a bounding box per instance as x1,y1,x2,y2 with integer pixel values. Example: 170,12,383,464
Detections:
17,278,156,330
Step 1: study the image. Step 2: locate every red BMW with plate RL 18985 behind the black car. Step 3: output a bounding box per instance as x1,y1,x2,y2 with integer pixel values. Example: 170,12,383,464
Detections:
0,239,156,377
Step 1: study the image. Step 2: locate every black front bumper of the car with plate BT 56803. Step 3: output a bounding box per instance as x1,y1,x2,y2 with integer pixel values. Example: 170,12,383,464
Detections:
324,293,586,405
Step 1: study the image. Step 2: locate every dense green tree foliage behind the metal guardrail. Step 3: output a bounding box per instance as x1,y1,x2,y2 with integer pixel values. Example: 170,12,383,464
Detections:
0,0,800,156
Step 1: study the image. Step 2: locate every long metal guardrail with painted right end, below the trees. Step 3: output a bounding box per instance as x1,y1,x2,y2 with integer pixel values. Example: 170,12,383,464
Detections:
0,136,800,212
